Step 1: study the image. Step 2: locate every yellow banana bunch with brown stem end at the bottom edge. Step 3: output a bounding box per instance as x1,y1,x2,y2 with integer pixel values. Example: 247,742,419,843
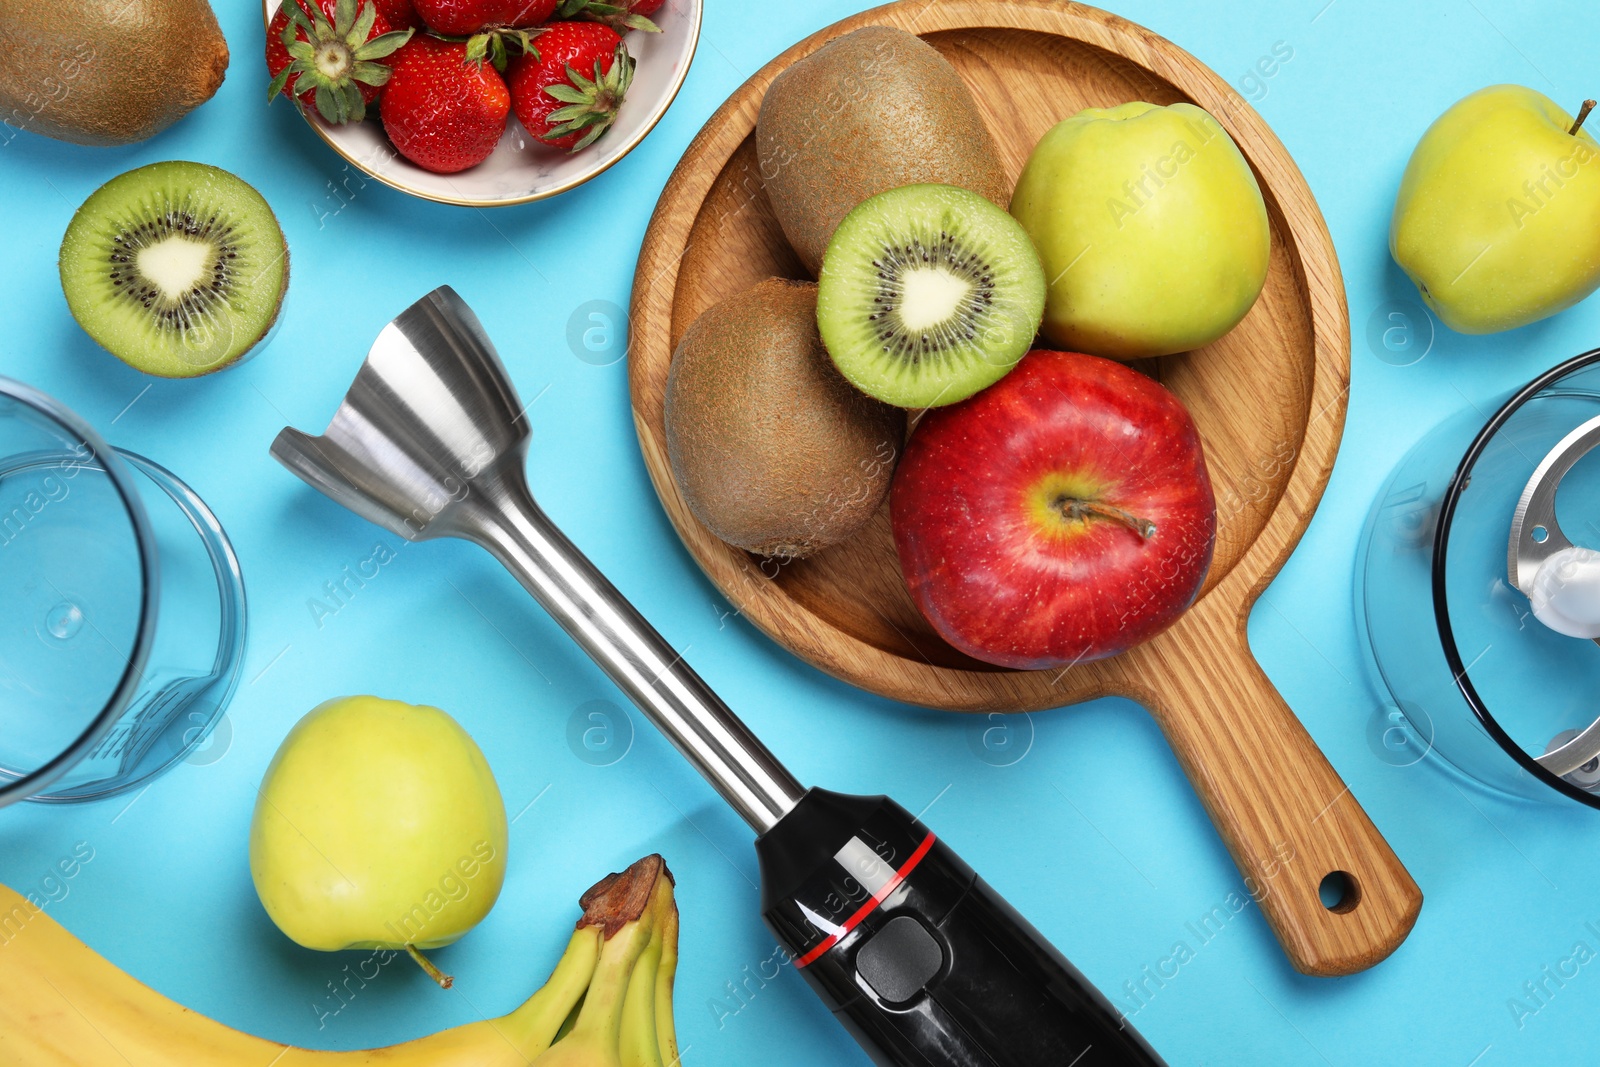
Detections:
0,856,678,1067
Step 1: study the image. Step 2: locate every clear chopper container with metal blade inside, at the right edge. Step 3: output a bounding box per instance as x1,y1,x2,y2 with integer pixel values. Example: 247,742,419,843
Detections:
1355,349,1600,808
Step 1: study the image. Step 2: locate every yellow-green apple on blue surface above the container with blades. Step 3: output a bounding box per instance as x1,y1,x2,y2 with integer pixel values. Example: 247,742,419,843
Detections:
1389,85,1600,333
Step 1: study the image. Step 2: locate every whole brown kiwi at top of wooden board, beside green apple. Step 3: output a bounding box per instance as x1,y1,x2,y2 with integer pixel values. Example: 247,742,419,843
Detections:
755,26,1011,275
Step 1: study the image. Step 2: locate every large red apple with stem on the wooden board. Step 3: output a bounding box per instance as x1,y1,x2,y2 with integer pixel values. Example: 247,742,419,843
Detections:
890,350,1216,670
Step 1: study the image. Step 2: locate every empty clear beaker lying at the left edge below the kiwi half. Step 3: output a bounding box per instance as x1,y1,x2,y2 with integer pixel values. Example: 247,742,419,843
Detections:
0,378,245,806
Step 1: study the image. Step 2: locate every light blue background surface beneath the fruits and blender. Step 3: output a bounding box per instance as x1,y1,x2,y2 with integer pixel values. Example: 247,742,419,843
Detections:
0,0,1600,1067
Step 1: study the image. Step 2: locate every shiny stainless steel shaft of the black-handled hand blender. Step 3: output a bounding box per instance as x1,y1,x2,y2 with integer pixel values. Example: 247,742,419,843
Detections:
272,286,805,833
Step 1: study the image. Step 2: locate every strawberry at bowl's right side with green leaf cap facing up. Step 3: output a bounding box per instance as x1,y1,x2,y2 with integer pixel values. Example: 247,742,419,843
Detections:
507,22,634,152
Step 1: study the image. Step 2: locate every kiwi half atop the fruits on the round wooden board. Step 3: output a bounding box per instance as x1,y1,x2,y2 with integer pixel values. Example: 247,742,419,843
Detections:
816,186,1045,408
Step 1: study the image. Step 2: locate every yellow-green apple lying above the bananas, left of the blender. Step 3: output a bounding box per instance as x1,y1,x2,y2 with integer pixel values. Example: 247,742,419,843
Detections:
250,696,506,952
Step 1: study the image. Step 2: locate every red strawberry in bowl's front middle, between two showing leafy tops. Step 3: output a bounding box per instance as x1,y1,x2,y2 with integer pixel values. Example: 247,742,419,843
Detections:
382,35,510,174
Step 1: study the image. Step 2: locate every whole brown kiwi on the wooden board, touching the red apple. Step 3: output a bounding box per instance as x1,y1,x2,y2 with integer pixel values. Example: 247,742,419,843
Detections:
666,278,906,558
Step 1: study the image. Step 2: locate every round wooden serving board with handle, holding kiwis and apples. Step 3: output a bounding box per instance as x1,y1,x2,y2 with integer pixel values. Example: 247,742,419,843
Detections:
629,0,1422,974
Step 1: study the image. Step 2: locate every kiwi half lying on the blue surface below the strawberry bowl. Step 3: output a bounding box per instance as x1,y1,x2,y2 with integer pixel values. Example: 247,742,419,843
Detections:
59,160,290,378
